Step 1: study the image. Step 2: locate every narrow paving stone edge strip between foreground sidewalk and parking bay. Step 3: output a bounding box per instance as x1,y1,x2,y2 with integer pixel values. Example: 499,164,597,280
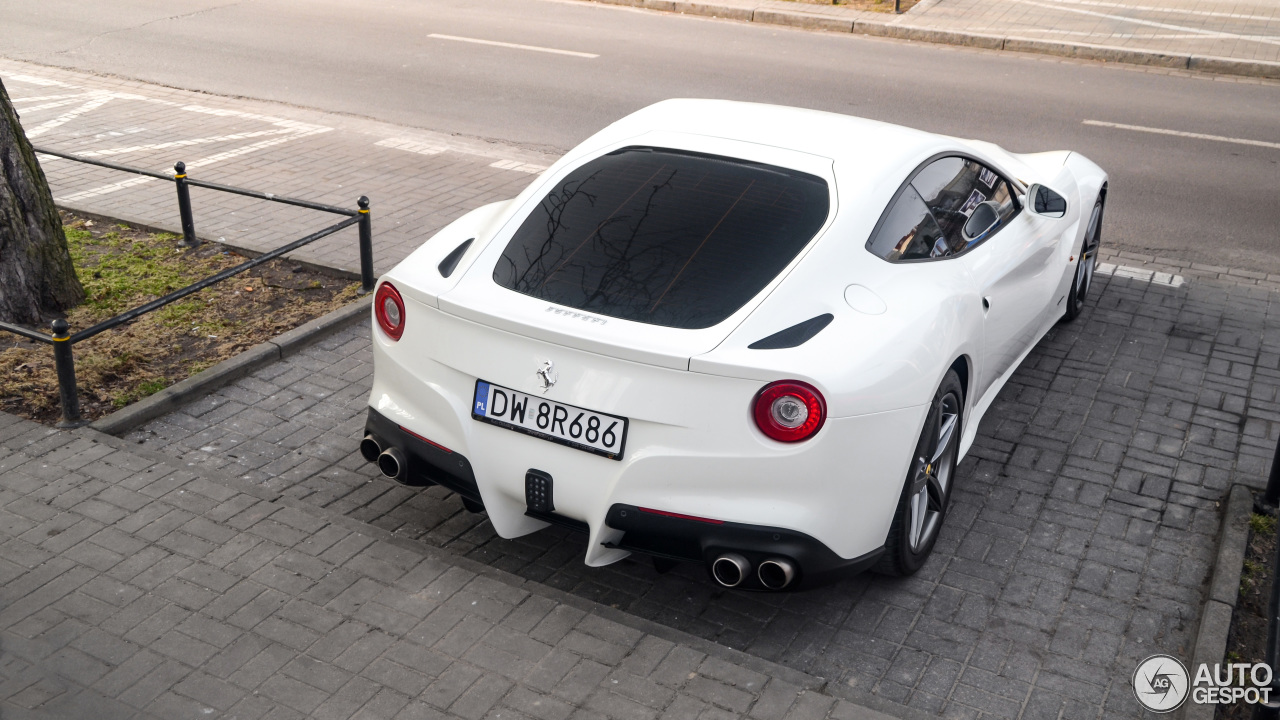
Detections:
70,425,936,720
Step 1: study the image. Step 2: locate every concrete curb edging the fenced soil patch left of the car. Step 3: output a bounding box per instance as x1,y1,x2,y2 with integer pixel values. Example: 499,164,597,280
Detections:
88,295,372,436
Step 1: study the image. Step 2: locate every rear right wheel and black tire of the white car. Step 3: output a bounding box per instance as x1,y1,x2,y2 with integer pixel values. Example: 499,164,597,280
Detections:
872,370,964,577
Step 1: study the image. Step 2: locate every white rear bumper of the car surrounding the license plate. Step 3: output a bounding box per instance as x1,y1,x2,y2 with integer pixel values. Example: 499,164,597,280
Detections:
369,301,927,586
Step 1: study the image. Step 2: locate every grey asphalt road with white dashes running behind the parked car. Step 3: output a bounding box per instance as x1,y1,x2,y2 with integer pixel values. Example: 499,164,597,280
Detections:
0,0,1280,273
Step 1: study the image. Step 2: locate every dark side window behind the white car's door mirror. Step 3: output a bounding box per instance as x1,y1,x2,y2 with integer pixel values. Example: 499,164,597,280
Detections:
870,158,1019,261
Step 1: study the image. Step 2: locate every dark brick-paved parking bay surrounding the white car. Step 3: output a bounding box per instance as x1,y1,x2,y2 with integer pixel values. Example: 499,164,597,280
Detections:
125,249,1280,720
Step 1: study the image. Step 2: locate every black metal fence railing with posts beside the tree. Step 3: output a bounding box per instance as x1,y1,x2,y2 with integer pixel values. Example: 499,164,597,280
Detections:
0,147,374,428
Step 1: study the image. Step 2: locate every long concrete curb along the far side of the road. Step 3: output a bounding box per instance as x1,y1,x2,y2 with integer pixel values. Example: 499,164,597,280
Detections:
588,0,1280,79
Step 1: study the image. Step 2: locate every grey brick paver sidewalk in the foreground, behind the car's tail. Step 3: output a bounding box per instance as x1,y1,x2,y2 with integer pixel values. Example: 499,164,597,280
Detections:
0,414,911,720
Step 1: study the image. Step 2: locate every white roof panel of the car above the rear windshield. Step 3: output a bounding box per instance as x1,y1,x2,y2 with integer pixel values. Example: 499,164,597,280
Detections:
596,99,961,181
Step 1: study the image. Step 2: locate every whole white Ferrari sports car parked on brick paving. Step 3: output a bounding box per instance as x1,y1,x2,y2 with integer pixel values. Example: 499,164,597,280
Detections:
361,100,1107,591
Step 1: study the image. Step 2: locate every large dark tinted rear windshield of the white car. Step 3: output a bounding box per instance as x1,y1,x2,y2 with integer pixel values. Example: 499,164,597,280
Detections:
493,147,829,329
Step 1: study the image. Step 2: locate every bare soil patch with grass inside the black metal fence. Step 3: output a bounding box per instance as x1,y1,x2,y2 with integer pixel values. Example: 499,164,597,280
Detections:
0,211,360,423
